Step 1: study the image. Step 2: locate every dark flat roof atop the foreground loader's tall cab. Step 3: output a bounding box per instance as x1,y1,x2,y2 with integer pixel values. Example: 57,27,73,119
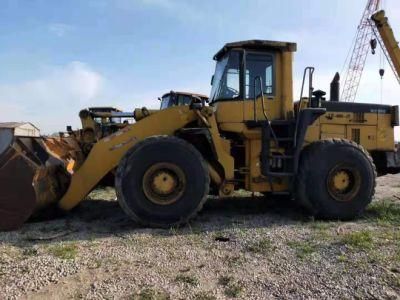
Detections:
214,40,297,60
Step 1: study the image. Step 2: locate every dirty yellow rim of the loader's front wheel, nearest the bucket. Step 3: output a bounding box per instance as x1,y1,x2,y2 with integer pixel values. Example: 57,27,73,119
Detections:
143,162,186,205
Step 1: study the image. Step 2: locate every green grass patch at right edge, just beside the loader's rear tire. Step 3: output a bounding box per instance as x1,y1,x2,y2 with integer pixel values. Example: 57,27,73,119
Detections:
366,199,400,225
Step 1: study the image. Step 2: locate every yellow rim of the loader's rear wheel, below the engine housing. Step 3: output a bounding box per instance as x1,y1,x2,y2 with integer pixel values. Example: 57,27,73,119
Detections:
327,163,361,202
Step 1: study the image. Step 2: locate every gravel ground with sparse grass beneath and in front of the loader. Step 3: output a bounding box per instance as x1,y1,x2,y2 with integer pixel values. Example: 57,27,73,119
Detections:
0,175,400,299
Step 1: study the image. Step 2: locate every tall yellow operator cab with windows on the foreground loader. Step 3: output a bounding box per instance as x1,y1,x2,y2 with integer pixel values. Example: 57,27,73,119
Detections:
210,40,296,125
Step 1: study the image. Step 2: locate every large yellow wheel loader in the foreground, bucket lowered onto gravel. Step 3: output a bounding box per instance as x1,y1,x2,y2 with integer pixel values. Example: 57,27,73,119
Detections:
0,40,400,230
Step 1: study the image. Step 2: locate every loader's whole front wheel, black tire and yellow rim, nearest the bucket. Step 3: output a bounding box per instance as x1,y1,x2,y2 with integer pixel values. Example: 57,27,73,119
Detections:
115,136,210,227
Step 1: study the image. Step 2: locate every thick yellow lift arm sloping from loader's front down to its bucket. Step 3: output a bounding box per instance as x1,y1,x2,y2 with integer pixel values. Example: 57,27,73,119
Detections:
59,106,197,210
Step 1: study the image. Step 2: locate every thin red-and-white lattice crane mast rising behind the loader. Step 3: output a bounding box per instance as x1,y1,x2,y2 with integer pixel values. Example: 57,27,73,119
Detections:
341,0,380,102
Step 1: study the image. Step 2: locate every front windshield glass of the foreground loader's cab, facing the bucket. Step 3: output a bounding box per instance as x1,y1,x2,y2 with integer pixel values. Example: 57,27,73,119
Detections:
210,51,240,101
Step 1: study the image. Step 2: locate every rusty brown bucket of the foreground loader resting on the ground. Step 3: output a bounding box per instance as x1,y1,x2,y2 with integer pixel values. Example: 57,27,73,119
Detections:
0,130,70,231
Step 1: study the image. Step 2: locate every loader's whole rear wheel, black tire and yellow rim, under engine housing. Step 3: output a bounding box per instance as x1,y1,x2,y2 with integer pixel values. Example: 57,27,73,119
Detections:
296,139,376,220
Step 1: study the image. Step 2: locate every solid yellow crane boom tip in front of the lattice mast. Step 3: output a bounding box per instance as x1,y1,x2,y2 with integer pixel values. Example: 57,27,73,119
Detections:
371,10,400,83
